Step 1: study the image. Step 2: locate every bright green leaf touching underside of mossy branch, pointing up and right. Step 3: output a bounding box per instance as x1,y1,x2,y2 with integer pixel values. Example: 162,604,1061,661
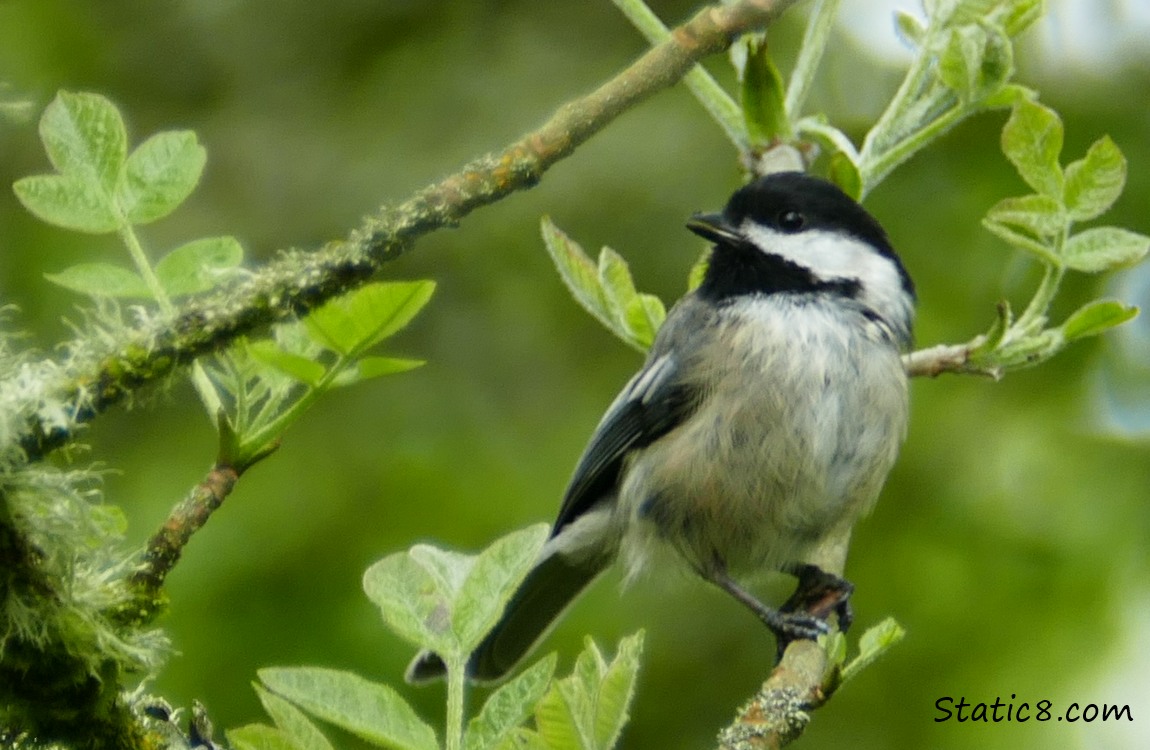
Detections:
304,281,435,357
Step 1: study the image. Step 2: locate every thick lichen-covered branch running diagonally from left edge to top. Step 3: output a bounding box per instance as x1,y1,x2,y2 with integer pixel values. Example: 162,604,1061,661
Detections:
0,0,797,461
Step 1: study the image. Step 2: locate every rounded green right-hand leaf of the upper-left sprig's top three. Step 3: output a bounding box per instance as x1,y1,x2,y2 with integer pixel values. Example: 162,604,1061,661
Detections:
116,130,207,224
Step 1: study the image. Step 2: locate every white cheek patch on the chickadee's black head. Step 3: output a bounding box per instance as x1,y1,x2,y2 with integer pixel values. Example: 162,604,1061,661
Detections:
741,221,911,335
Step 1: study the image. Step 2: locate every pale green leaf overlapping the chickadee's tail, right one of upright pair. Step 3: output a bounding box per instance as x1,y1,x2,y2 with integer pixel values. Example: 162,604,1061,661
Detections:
452,523,551,652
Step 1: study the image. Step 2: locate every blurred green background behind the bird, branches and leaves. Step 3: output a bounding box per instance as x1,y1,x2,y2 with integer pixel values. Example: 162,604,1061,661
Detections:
0,0,1150,749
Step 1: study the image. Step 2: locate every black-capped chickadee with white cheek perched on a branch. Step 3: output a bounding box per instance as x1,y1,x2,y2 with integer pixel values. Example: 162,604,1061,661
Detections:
408,173,914,681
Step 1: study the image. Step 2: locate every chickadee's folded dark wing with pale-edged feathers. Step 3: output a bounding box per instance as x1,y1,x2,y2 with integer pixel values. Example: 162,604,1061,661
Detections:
551,353,698,536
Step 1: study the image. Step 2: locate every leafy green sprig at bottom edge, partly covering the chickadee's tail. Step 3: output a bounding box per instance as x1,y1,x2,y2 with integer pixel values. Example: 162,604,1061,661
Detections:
238,525,642,750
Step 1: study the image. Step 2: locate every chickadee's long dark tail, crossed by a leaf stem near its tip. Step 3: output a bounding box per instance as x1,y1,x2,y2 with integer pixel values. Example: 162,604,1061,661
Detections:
406,552,611,682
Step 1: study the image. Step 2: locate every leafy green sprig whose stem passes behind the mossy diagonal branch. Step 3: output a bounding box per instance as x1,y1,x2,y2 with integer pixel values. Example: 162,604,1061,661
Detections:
14,91,435,470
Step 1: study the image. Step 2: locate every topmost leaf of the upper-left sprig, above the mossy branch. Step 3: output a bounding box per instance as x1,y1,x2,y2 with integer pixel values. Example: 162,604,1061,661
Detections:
40,91,128,196
